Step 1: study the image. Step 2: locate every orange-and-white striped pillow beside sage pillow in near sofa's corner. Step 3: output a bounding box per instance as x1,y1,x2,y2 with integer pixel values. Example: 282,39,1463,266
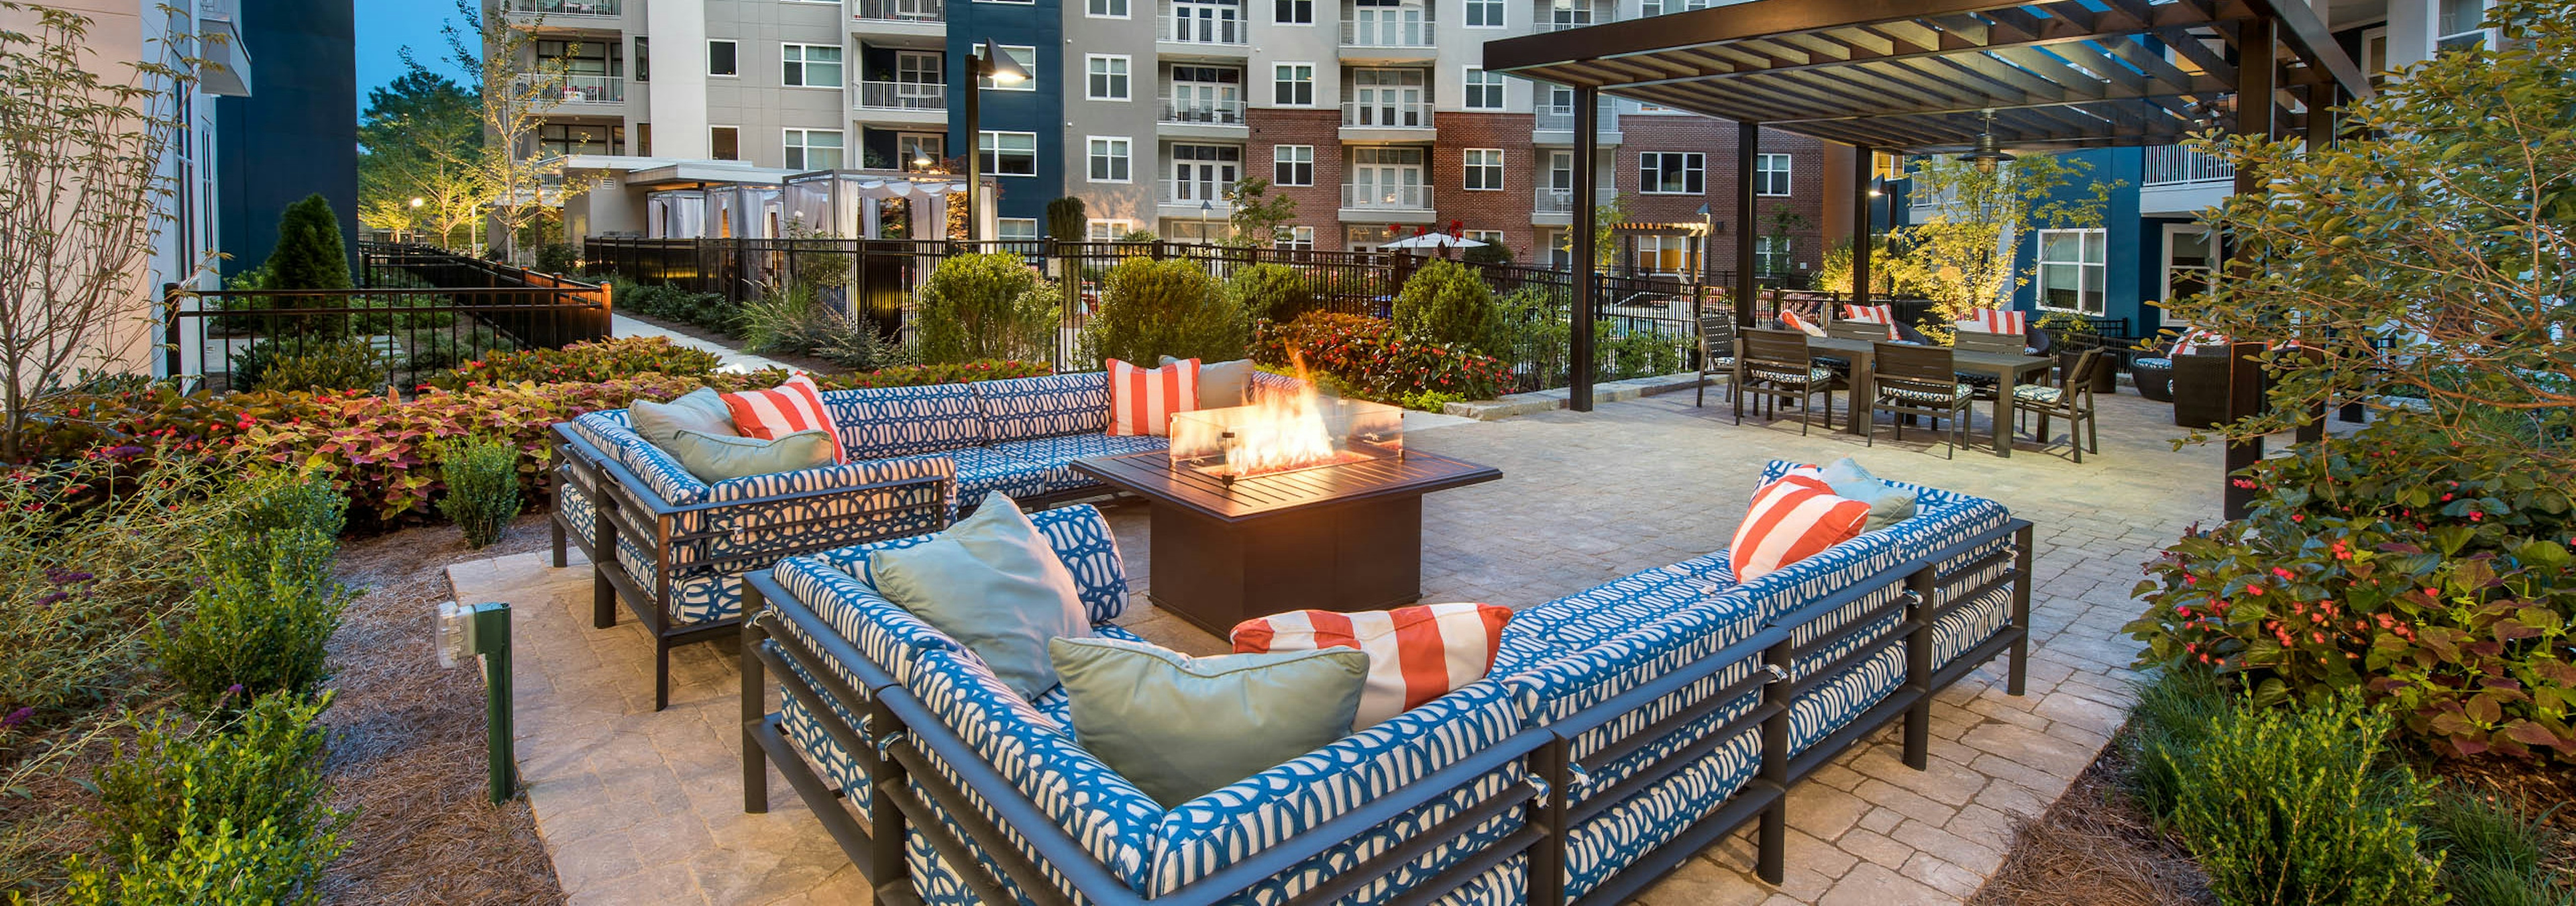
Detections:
1232,605,1512,731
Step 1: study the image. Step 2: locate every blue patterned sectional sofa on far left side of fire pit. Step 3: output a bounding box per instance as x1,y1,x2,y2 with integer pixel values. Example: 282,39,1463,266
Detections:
551,370,1293,708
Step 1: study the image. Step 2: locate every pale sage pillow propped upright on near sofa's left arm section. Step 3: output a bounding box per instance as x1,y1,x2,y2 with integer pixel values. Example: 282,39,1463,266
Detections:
868,494,1092,697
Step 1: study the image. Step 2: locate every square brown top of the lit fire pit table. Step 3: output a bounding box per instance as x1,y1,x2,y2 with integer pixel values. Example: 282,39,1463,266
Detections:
1074,450,1502,523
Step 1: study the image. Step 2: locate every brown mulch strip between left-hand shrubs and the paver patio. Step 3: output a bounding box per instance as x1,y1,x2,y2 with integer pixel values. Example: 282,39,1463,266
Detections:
322,515,564,903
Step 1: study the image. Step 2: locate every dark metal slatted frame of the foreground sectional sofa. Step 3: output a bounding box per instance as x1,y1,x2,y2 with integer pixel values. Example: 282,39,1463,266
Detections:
742,520,2030,906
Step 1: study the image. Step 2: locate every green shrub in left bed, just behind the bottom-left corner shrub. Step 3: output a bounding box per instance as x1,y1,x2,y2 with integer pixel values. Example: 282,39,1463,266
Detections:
154,525,356,711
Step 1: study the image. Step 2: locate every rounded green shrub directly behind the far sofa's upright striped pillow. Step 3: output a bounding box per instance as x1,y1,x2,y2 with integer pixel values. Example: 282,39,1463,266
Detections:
1082,258,1247,366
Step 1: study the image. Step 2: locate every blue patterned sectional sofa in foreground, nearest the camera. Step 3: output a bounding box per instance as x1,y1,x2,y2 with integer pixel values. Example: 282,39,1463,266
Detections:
742,463,2030,906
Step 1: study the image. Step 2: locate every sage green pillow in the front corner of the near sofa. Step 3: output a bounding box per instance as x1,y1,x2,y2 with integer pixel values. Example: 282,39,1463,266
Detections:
1046,638,1368,808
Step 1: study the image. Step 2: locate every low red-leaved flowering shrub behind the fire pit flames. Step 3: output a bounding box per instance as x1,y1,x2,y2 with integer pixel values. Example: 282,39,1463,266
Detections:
1252,314,1512,401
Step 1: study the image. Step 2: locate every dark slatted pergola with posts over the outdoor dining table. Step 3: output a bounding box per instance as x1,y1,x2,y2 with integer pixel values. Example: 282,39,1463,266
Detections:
1484,0,2370,432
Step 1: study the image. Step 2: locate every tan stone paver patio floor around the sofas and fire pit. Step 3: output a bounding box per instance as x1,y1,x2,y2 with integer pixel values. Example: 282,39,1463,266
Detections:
448,394,2256,906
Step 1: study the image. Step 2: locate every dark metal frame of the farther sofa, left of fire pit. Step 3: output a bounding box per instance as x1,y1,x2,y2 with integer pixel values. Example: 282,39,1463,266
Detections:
546,422,951,711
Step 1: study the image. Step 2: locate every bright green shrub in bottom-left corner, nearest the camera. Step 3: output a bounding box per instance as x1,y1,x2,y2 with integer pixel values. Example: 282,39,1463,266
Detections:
90,693,345,867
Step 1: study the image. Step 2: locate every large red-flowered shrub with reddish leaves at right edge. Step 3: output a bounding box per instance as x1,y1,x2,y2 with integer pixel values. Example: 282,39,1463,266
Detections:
2128,419,2576,762
